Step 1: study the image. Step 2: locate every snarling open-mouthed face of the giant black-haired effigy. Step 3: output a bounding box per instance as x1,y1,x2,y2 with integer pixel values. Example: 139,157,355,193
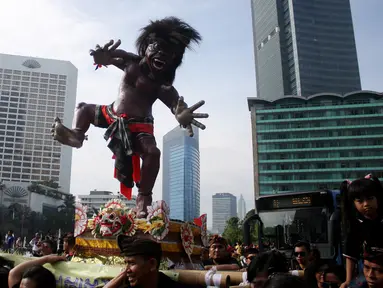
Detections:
145,38,177,73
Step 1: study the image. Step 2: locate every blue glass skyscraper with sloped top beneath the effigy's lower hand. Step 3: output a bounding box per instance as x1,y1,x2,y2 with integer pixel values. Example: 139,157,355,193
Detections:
162,127,200,221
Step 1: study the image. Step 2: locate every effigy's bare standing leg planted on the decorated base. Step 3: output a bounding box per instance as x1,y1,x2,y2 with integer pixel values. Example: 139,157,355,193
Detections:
134,134,161,218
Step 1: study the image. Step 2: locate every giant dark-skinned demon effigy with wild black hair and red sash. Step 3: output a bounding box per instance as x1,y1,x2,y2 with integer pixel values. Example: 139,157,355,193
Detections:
52,17,209,218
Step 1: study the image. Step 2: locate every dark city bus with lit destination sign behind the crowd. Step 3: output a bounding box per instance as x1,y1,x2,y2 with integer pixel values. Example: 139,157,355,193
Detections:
243,190,343,264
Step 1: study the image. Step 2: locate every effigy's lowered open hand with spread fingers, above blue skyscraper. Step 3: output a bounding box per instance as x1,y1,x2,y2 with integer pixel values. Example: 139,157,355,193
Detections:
175,96,209,137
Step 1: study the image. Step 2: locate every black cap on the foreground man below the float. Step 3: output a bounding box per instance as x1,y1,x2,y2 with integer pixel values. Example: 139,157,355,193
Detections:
117,234,162,259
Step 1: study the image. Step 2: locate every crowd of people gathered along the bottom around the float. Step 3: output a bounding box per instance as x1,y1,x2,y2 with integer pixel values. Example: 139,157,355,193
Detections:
0,175,383,288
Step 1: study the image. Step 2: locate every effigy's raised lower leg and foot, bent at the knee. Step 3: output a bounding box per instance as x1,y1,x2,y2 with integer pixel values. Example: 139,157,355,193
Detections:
52,103,96,148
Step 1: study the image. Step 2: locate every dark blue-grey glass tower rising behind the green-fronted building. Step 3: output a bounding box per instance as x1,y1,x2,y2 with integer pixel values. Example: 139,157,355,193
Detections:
251,0,361,100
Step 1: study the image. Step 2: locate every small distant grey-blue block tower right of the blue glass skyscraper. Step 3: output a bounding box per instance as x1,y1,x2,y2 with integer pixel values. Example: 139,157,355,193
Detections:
212,193,237,234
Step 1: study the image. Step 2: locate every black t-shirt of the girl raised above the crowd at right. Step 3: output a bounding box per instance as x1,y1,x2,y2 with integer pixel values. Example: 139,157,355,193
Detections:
344,217,383,260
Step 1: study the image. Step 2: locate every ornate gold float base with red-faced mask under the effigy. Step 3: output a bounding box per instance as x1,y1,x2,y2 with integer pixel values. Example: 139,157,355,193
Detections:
75,200,207,266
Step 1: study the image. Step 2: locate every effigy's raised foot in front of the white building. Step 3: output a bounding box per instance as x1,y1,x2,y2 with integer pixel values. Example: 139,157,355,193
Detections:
51,117,87,148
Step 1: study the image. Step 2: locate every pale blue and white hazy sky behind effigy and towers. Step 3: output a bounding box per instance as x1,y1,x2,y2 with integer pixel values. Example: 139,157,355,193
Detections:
0,0,383,226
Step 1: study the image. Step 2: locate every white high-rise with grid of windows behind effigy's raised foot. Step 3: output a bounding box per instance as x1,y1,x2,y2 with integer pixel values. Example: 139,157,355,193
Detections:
0,54,77,193
